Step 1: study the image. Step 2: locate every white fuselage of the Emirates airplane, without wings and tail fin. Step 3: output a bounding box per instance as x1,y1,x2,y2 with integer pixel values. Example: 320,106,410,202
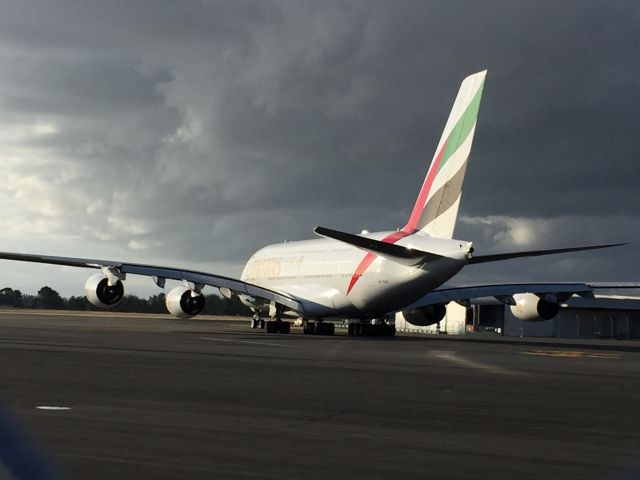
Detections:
241,232,469,318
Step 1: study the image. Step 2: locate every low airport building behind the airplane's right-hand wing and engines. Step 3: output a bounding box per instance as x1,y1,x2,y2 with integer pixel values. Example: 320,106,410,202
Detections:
395,296,640,340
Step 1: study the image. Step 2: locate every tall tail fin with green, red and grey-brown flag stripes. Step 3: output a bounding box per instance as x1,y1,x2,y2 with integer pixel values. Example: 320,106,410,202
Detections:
402,70,487,238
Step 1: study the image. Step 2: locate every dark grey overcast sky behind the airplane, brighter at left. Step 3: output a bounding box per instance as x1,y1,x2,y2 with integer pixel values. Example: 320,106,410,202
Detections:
0,0,640,296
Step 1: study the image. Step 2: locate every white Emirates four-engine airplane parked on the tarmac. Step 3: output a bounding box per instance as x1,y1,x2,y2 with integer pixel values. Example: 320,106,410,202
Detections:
0,70,635,336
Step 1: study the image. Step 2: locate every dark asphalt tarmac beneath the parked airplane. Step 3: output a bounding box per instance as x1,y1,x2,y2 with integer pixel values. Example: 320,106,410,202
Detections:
0,311,640,480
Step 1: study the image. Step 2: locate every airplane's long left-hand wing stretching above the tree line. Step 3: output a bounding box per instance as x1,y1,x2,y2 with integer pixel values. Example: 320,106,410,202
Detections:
0,252,304,312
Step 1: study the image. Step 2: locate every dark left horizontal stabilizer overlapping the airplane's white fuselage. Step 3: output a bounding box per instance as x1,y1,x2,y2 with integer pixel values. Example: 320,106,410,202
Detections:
313,227,442,266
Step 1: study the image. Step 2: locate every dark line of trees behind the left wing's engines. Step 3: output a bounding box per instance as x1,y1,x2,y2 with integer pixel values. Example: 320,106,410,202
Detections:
0,285,251,316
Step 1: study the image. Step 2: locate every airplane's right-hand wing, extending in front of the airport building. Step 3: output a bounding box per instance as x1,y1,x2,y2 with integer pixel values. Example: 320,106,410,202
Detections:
406,282,640,309
